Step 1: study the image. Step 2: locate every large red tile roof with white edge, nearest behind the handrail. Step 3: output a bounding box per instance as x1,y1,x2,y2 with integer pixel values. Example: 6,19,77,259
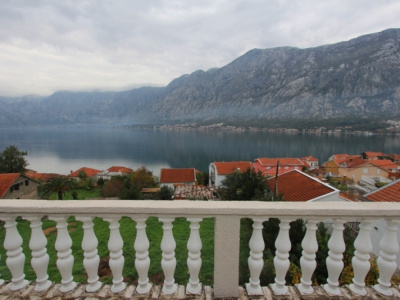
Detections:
267,170,339,202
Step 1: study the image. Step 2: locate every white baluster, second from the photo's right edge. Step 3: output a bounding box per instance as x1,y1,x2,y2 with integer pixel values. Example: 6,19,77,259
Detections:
350,220,373,296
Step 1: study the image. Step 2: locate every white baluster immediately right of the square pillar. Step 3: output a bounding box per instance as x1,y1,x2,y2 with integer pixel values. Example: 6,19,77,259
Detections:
246,218,265,295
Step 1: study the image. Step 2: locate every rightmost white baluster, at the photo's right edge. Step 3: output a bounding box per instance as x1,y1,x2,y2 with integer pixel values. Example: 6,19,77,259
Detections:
374,220,400,296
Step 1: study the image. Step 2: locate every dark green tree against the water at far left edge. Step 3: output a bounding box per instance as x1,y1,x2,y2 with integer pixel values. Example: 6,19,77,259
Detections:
0,145,29,173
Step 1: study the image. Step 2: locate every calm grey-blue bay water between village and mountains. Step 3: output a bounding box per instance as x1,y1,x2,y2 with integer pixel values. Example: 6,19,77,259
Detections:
0,128,400,176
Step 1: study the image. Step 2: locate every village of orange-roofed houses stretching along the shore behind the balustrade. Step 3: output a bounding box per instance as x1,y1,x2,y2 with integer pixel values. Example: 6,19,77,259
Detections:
0,151,400,201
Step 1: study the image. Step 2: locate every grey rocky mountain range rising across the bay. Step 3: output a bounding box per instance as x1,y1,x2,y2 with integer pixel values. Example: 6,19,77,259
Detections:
0,29,400,126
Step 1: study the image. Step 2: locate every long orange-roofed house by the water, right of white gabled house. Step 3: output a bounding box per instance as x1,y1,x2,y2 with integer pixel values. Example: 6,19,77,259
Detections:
253,157,307,177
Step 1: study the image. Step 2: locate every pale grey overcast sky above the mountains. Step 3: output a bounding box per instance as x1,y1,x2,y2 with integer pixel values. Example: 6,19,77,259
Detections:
0,0,400,96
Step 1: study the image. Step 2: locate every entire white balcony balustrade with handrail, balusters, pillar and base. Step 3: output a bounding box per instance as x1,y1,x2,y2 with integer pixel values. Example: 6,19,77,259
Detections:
0,200,400,299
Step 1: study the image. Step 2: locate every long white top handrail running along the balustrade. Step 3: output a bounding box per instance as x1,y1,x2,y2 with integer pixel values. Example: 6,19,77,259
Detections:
0,199,400,219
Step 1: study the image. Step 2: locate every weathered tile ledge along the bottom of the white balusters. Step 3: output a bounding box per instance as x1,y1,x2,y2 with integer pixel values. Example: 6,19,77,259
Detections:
0,283,400,300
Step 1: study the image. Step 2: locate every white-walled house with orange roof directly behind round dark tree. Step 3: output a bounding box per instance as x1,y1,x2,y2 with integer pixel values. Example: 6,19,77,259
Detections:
208,161,253,188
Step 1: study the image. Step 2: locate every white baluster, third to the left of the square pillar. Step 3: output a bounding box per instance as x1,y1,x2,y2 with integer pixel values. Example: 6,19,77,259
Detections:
134,218,152,294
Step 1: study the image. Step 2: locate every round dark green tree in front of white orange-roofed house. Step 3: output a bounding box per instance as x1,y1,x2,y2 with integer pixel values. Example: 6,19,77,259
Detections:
220,168,266,200
